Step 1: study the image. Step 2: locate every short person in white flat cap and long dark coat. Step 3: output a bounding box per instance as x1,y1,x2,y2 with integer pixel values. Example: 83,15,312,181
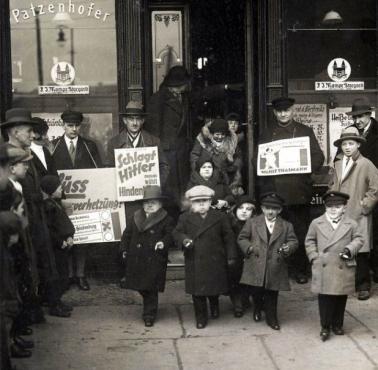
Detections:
173,185,236,329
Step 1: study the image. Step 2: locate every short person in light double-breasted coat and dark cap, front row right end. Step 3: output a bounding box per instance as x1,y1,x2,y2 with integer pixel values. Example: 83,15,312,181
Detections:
305,191,364,341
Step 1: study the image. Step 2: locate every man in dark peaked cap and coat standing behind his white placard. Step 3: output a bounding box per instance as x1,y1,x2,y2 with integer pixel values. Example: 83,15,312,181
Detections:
257,96,324,284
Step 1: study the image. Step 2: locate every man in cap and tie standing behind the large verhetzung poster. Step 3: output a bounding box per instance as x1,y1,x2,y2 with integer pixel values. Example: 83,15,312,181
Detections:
52,110,102,290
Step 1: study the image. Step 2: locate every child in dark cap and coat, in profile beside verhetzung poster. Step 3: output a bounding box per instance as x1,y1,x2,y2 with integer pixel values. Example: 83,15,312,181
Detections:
41,175,75,317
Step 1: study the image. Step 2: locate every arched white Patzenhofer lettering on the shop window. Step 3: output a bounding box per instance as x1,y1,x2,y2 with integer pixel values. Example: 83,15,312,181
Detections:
11,0,111,23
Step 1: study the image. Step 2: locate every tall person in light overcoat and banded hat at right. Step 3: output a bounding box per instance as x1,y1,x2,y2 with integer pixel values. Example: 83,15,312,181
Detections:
330,126,378,300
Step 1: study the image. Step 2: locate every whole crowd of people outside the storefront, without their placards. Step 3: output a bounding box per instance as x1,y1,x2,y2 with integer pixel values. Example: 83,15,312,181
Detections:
0,66,378,369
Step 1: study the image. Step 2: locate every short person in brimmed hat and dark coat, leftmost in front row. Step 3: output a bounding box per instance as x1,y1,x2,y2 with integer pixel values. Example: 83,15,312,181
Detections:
121,186,174,327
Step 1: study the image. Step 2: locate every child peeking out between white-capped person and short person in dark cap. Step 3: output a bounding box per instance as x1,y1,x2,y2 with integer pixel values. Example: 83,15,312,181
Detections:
229,195,256,318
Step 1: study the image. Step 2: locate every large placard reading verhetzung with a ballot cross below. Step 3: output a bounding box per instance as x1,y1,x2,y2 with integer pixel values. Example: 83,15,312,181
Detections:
58,168,126,244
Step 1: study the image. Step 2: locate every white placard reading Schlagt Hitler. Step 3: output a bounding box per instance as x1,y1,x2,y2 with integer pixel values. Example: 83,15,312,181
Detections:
114,146,160,202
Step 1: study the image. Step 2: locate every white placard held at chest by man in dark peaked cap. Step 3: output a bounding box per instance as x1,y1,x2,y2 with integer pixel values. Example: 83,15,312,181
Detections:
257,136,311,176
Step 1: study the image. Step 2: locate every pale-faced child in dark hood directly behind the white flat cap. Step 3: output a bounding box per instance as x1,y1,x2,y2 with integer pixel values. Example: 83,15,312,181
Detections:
188,158,234,210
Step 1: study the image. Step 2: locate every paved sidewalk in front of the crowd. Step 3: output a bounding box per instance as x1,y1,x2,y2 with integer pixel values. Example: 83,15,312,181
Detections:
15,281,378,370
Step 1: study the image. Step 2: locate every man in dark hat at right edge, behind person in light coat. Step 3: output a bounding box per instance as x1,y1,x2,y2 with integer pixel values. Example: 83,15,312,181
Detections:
347,98,378,283
